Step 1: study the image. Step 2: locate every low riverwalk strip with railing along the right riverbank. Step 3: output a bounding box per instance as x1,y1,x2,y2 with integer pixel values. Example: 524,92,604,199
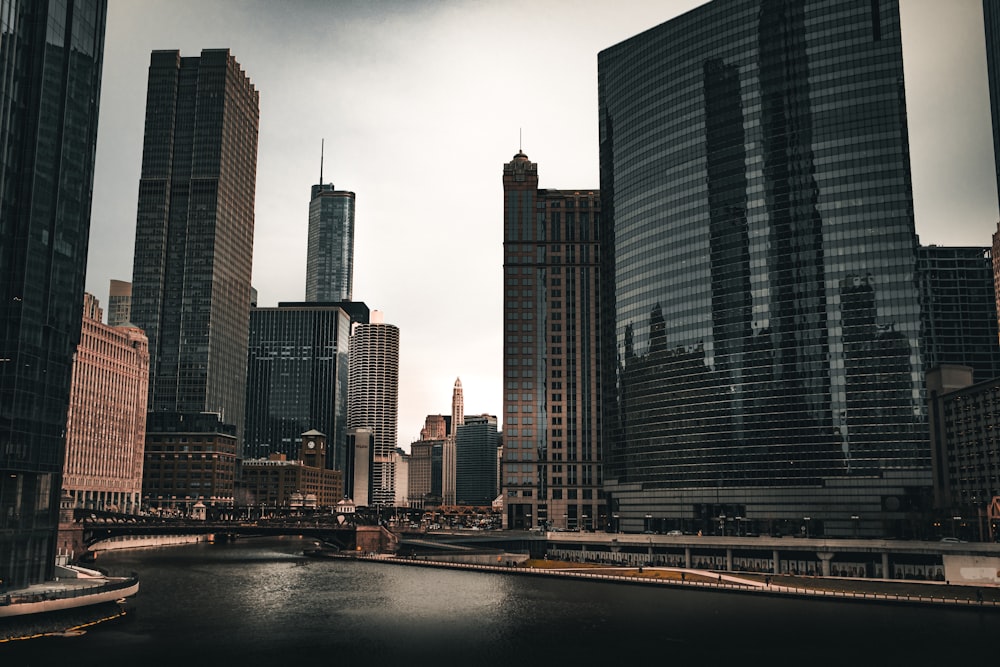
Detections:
324,553,1000,612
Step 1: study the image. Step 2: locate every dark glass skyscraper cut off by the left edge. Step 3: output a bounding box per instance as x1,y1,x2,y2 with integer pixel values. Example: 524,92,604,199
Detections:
0,0,107,587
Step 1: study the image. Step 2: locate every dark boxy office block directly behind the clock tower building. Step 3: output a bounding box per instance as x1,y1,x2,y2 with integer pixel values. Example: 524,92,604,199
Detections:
243,303,351,470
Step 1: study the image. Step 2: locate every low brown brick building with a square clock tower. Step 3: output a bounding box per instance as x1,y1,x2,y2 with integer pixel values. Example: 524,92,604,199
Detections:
240,429,344,514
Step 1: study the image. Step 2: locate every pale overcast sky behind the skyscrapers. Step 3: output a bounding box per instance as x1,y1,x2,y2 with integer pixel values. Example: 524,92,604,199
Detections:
87,0,998,449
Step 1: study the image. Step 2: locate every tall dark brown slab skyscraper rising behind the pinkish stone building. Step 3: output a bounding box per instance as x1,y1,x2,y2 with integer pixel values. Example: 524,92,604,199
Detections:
132,49,258,440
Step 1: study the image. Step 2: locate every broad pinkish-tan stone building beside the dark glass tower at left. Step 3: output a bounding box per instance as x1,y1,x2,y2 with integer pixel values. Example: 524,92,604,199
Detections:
62,294,149,513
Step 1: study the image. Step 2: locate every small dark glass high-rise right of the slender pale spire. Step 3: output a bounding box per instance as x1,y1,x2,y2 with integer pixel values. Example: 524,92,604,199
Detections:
455,415,500,507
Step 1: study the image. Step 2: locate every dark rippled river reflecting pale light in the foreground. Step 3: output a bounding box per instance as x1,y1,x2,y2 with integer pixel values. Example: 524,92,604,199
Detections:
0,538,1000,667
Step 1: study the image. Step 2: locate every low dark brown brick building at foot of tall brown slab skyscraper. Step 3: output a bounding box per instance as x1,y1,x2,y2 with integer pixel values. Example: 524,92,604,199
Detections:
142,412,239,515
